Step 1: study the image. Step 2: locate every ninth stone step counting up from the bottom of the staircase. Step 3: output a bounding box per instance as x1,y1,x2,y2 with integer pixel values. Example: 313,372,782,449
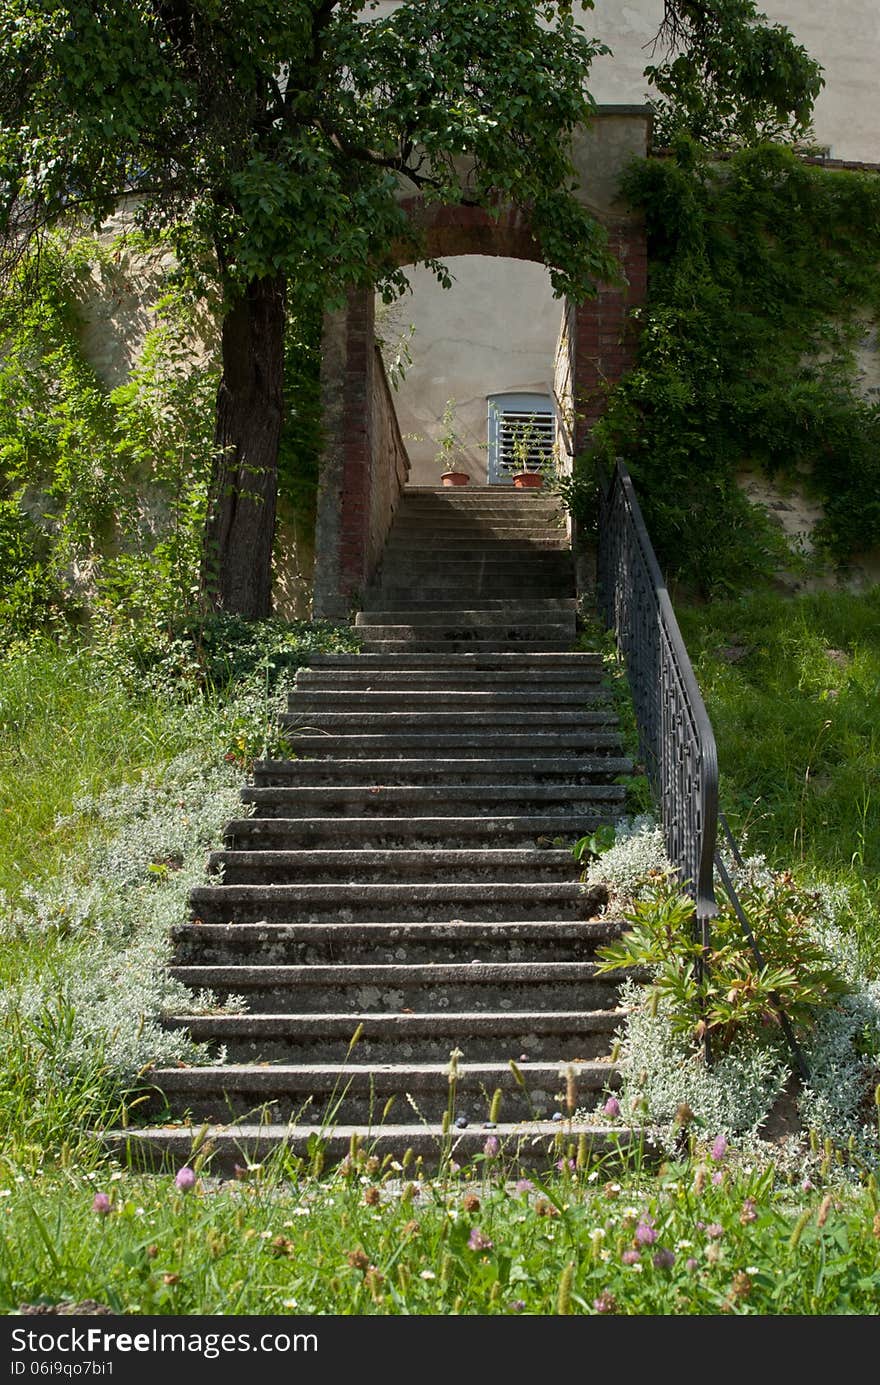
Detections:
239,783,626,814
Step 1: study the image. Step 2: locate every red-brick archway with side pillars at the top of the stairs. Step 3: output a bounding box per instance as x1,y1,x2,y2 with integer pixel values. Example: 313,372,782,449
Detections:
313,108,647,619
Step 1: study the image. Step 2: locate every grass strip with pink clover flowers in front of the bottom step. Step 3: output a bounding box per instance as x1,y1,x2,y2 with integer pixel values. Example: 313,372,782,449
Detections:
0,1158,880,1314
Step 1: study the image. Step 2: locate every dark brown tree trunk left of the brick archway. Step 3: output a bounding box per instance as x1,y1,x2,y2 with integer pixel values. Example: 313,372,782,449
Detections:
201,277,285,620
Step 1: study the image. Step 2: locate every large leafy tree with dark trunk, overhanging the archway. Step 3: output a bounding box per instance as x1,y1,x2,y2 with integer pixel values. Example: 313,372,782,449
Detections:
0,0,819,616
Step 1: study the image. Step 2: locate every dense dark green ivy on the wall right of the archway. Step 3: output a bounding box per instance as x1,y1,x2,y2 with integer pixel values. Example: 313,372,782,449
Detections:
582,140,880,593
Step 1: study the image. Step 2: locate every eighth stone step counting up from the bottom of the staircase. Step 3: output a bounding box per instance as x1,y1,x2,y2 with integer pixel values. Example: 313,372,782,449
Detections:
223,807,614,850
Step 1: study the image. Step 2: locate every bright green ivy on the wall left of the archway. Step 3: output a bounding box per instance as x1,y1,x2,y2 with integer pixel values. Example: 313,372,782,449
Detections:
0,233,320,648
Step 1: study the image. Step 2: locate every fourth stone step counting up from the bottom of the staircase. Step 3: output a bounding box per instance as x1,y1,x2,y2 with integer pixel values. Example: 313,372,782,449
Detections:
169,958,622,1014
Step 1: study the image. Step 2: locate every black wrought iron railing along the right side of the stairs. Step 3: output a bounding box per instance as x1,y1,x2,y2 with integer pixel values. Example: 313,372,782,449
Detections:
597,461,718,943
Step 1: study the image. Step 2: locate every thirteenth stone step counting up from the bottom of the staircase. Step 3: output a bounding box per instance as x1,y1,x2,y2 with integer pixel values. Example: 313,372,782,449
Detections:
287,681,611,717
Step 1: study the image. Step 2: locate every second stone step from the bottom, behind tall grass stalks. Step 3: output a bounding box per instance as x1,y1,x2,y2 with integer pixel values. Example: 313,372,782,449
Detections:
141,1053,621,1125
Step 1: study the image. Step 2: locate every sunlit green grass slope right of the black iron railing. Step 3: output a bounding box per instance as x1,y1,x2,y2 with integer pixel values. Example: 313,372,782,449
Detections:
678,587,880,956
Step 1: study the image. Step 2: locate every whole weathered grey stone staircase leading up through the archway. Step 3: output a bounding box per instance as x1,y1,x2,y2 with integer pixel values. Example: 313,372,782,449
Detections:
121,488,640,1168
